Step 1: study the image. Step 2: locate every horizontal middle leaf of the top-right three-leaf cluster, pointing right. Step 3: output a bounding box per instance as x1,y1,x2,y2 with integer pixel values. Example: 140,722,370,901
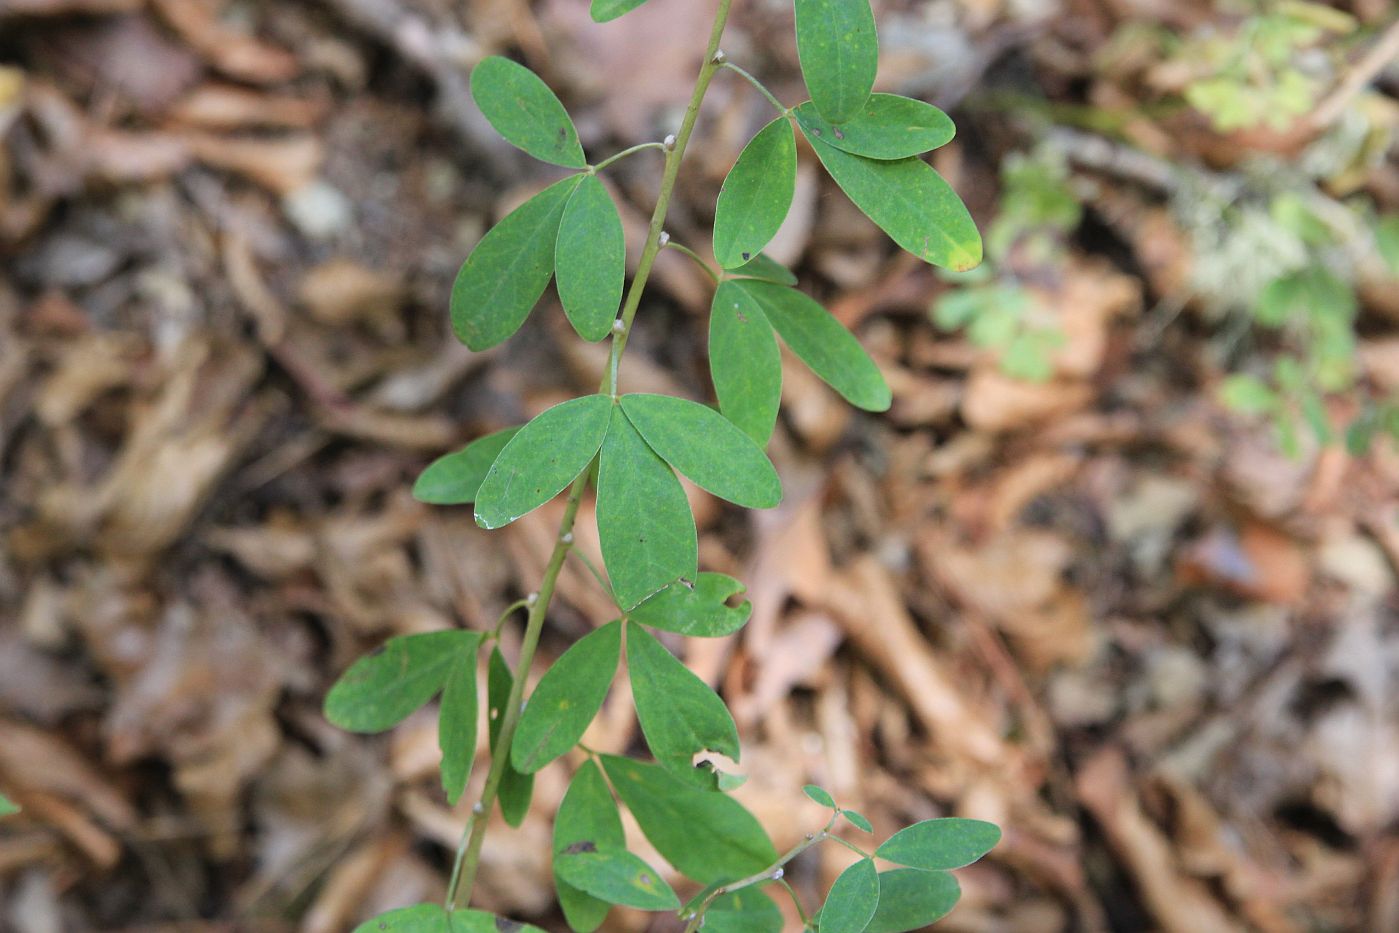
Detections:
793,94,957,159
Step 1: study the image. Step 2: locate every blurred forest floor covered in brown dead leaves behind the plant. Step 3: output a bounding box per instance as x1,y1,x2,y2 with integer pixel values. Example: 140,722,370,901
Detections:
0,0,1399,933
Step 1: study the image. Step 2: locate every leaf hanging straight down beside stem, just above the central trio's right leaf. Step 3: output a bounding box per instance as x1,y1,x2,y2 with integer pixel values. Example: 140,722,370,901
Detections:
709,276,782,446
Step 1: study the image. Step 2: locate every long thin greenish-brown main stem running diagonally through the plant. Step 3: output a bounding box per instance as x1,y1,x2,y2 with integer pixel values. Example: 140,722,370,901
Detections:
446,0,733,911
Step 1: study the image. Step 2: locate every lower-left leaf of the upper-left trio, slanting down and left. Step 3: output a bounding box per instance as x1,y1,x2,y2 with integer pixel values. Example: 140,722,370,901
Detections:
452,175,581,351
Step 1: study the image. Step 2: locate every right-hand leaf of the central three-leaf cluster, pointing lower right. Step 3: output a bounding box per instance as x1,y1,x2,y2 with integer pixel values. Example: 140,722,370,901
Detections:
621,394,782,511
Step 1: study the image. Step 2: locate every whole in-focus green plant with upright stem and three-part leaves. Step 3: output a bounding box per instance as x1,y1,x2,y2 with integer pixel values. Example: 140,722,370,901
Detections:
325,0,1000,933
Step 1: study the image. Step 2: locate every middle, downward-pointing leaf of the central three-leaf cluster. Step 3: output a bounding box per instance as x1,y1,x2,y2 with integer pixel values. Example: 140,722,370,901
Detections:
597,407,700,611
